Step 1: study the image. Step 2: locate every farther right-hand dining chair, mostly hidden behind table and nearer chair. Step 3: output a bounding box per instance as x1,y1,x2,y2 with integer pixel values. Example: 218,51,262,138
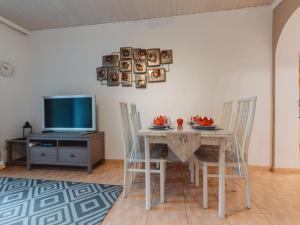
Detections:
189,100,233,187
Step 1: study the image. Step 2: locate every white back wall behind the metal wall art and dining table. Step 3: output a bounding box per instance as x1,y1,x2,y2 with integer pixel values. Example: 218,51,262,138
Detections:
31,7,272,165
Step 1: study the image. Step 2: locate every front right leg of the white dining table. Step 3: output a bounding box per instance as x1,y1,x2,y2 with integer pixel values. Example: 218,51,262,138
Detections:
219,138,225,218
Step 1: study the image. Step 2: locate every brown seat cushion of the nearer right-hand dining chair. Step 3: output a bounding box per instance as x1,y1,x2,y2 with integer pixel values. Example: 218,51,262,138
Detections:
194,145,237,163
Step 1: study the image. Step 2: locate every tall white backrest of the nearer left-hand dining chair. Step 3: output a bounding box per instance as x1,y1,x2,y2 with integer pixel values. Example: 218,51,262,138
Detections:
119,102,134,161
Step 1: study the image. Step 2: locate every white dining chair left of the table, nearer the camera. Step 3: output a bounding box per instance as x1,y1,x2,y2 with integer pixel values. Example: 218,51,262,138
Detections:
119,102,168,202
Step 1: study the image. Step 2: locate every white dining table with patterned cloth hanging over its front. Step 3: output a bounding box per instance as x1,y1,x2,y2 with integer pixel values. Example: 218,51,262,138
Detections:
138,124,232,218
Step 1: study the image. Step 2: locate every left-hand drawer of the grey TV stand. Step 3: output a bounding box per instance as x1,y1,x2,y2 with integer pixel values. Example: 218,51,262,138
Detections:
30,147,57,162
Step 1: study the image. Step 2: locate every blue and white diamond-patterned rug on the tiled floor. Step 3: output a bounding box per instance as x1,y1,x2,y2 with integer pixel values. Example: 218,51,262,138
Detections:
0,177,122,225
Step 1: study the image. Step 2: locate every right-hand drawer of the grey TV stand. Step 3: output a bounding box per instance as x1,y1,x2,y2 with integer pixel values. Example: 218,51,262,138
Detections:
58,148,88,163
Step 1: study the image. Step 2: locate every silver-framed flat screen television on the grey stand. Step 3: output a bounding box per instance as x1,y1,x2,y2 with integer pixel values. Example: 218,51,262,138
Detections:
42,95,96,132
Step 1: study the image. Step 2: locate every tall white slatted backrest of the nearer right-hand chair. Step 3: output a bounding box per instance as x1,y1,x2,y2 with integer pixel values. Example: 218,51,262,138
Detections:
234,97,257,169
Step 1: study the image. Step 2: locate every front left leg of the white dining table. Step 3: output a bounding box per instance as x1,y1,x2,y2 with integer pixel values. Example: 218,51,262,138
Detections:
145,137,151,209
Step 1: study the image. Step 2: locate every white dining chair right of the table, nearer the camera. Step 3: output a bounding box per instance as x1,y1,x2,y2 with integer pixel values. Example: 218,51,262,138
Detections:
194,97,257,208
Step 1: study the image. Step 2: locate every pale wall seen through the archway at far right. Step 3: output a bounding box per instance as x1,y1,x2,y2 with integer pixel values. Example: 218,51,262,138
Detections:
275,8,300,168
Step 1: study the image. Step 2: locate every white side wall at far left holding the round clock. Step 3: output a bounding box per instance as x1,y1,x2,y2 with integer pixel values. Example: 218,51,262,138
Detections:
0,23,31,160
